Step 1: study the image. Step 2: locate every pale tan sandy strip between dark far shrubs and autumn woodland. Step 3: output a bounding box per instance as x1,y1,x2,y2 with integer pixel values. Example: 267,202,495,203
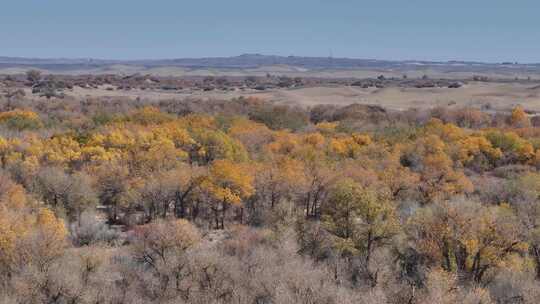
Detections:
27,82,540,111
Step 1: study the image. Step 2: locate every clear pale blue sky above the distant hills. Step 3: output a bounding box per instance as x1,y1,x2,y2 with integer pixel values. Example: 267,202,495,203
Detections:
0,0,540,63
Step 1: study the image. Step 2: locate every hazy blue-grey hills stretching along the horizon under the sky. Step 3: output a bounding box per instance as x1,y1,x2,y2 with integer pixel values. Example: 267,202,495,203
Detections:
0,54,540,76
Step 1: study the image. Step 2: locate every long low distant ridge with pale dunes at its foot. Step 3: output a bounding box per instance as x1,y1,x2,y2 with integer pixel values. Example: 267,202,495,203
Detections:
0,54,540,79
